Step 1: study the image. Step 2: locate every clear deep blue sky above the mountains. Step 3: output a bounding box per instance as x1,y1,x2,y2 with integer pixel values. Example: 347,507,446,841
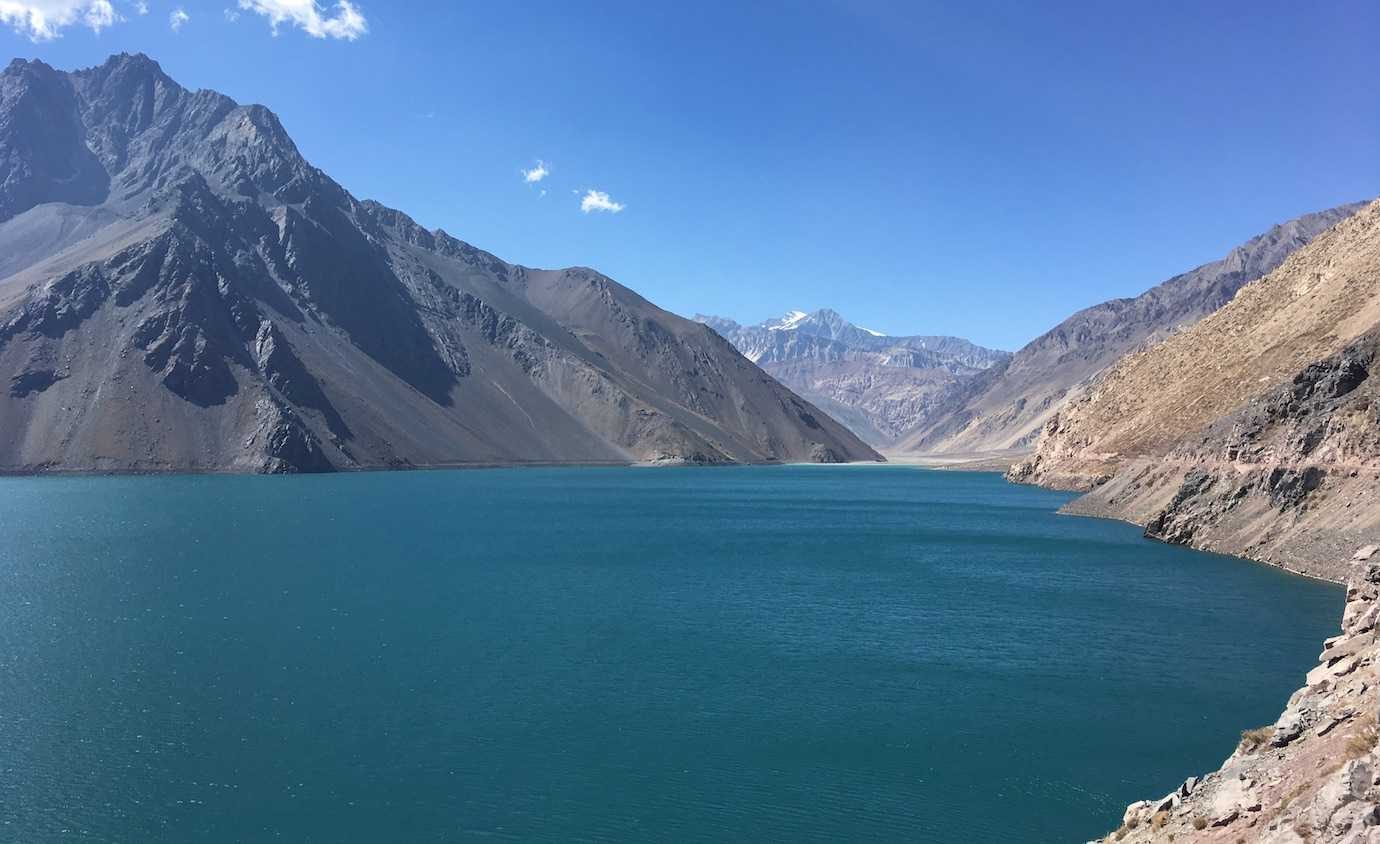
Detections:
0,0,1380,349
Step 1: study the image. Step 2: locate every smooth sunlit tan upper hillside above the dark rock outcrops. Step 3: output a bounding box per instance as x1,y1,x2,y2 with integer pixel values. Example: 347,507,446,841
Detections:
1012,201,1380,490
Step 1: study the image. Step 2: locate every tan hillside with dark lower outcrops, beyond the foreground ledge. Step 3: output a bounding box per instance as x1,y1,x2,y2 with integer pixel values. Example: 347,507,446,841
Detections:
1010,200,1380,579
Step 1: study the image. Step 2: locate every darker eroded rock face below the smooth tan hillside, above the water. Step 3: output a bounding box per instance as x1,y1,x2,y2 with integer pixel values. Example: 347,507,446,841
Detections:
1043,331,1380,581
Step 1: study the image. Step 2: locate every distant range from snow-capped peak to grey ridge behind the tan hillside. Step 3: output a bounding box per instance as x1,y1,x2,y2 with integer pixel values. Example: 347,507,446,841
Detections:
694,203,1365,459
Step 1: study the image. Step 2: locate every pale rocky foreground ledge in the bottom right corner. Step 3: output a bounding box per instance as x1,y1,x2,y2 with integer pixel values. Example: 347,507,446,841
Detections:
1104,545,1380,844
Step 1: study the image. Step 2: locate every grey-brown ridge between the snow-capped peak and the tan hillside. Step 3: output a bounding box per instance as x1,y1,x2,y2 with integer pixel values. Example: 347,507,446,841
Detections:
896,203,1365,454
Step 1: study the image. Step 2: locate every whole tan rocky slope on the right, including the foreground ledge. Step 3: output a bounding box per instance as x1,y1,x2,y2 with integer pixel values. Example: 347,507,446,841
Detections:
1007,200,1380,844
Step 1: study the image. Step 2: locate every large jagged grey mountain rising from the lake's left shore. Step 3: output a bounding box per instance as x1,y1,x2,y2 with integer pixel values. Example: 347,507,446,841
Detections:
0,55,878,472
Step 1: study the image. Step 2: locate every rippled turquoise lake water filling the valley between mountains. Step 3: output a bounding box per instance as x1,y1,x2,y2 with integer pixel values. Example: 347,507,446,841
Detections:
0,466,1343,843
